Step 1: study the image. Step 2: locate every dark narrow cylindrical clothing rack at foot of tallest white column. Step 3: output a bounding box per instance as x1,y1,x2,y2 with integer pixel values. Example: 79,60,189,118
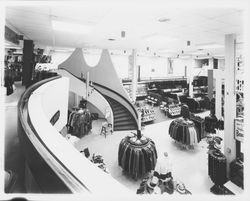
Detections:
208,150,227,186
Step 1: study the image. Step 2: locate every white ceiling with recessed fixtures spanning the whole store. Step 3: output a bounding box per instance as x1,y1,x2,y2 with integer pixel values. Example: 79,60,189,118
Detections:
6,3,244,57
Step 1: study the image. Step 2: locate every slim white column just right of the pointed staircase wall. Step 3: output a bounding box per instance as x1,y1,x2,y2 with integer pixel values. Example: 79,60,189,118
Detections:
129,49,138,101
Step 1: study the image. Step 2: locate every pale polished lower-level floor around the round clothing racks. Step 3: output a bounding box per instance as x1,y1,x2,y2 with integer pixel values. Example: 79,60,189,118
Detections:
75,108,227,195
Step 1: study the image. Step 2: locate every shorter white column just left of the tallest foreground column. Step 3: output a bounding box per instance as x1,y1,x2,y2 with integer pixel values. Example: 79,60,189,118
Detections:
214,70,222,119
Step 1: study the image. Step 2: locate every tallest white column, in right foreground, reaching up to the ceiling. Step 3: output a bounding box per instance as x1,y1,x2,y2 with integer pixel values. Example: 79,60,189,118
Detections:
224,34,236,174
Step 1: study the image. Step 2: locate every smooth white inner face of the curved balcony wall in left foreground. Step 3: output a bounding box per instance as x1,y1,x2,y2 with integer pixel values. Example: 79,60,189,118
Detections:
28,78,131,195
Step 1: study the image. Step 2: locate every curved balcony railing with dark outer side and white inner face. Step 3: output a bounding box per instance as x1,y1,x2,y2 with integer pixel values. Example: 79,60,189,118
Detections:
18,76,130,195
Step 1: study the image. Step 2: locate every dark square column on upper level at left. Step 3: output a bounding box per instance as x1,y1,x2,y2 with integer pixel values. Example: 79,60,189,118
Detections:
22,40,34,87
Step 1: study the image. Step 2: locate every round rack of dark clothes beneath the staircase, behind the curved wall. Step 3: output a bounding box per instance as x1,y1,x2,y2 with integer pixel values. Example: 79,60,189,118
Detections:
67,109,92,137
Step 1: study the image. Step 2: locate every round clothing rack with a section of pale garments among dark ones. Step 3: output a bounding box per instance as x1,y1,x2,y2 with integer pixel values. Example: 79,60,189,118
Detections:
169,118,201,145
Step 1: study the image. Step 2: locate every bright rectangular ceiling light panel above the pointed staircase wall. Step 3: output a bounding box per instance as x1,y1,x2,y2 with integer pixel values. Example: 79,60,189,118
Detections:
52,20,92,34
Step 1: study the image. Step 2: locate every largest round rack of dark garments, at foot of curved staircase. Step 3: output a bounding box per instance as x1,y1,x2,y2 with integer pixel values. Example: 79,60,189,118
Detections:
118,135,157,179
